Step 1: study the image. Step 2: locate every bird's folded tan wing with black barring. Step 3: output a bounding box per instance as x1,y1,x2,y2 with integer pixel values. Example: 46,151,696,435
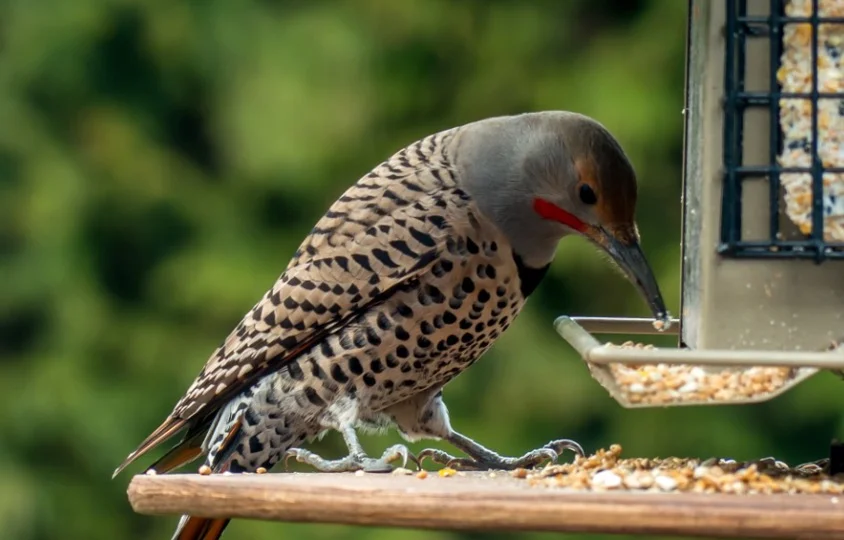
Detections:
115,188,479,474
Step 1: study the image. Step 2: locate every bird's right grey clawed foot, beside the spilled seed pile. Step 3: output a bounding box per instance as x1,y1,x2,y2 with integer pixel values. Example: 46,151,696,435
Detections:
418,439,584,471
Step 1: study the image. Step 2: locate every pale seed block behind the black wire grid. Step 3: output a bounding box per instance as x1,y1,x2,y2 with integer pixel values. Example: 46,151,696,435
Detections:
777,0,844,241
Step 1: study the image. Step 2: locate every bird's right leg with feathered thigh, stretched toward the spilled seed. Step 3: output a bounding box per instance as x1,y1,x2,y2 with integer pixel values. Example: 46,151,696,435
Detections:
389,389,583,470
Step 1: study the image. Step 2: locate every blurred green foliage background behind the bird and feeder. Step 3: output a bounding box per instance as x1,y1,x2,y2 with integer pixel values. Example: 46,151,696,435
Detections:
0,0,844,540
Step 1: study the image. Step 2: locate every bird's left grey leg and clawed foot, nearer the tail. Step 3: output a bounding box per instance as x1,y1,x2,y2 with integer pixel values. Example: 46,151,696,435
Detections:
284,425,416,472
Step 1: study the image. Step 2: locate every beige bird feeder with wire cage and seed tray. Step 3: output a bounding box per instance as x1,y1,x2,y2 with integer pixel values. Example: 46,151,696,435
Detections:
555,0,844,407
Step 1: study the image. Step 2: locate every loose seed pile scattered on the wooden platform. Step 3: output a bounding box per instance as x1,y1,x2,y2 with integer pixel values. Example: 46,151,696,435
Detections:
512,444,844,495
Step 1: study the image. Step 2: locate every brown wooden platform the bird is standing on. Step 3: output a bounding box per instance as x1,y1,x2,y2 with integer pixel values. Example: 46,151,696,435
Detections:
129,473,844,539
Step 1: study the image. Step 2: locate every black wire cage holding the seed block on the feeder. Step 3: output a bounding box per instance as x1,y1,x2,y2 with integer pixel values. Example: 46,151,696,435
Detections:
718,0,844,263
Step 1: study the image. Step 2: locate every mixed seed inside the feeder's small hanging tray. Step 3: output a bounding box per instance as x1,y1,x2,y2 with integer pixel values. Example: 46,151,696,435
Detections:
607,341,794,405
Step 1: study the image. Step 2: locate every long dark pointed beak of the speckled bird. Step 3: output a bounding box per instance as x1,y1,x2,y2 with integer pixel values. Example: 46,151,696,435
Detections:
586,227,669,322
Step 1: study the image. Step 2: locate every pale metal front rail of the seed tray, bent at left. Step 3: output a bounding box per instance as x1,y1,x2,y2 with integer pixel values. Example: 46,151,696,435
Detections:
554,316,844,369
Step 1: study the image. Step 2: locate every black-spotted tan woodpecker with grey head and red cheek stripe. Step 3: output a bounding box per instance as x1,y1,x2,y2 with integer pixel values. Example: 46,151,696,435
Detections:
114,110,670,540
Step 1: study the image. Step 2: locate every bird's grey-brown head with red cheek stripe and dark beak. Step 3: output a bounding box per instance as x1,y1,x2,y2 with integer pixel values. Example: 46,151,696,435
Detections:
452,111,666,319
